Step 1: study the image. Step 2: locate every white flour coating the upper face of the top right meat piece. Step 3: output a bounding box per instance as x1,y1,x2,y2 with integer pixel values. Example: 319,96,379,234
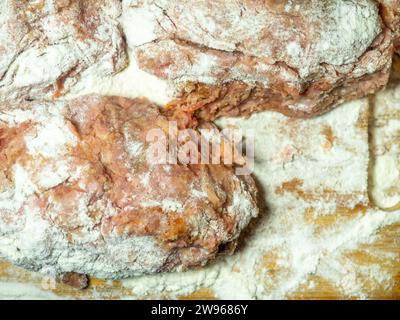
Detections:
122,0,382,87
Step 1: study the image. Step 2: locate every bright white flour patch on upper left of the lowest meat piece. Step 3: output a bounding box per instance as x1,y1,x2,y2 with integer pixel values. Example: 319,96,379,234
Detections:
0,103,76,210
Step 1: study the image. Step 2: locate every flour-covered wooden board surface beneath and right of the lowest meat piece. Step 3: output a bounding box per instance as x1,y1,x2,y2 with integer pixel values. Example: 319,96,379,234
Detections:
0,96,400,299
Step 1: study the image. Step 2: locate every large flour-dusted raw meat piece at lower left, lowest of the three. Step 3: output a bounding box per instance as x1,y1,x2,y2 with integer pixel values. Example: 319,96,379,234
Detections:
0,96,258,278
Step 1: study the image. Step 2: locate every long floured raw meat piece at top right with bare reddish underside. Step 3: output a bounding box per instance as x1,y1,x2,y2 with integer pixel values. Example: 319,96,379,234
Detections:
124,0,393,122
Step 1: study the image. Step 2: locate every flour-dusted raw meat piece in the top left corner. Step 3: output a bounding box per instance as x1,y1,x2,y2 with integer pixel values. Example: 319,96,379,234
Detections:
0,0,127,101
